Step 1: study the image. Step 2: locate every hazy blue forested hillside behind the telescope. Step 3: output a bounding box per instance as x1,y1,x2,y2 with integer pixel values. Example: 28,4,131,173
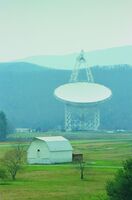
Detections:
0,62,132,130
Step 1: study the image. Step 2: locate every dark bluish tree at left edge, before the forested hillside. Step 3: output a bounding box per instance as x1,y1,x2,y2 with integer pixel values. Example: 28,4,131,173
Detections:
0,111,8,140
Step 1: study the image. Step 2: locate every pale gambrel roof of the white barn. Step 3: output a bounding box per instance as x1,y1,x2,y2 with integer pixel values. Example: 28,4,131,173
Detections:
36,136,72,151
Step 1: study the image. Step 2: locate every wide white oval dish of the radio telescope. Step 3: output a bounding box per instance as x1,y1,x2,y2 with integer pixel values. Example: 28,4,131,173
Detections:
54,82,112,104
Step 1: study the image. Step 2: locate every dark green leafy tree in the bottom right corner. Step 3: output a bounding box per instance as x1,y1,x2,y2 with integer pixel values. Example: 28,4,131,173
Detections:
106,159,132,200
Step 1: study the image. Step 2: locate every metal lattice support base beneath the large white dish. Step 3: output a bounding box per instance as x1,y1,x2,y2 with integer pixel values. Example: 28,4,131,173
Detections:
65,104,100,131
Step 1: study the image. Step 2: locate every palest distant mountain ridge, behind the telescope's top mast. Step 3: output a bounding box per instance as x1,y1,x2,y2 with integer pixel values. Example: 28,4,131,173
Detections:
23,46,132,70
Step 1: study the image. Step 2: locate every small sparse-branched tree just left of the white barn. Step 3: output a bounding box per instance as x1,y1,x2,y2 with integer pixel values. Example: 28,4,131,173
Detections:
2,144,25,180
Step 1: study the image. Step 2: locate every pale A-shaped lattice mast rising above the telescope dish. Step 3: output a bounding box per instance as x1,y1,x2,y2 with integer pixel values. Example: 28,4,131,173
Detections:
69,50,94,83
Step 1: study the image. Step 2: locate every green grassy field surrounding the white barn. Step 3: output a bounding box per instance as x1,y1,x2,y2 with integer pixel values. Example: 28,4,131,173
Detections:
0,135,132,200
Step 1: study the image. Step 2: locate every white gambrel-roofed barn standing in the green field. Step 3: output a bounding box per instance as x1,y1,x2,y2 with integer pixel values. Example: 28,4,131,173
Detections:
27,136,72,164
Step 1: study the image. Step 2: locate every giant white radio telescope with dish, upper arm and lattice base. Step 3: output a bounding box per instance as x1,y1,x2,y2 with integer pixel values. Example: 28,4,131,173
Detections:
54,51,112,131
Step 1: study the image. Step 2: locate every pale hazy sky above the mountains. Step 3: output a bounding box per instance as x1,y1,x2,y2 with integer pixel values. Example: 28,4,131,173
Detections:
0,0,132,61
